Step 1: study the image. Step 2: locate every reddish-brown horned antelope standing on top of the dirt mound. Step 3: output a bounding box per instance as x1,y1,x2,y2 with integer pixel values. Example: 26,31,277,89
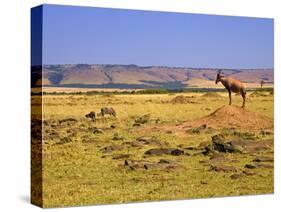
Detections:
216,70,246,108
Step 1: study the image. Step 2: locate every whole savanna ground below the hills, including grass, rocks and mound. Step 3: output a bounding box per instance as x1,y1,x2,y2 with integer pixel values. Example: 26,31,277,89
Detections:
32,88,274,207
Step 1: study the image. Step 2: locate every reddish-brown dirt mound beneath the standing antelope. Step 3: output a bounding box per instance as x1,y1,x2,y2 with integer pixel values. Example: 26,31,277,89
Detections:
183,105,273,130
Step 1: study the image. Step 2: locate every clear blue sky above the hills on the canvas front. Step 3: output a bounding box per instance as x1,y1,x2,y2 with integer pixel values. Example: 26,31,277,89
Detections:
40,5,274,69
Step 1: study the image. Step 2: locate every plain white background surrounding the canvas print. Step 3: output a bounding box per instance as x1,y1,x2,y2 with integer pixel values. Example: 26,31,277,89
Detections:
0,0,281,212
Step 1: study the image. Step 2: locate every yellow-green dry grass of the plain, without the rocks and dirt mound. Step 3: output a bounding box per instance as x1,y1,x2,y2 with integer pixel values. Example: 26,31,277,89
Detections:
33,92,273,207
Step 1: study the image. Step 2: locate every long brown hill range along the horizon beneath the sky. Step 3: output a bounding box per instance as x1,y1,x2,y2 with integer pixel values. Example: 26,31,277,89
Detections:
32,64,273,89
